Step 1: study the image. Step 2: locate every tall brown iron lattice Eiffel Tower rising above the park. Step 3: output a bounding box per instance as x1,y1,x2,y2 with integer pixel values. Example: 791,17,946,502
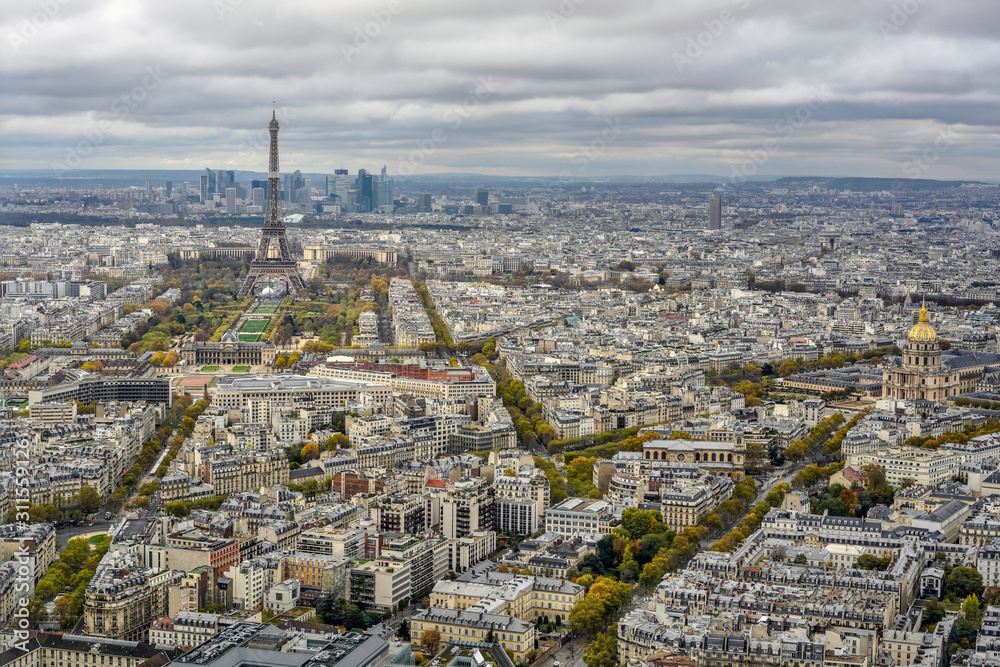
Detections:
240,112,306,296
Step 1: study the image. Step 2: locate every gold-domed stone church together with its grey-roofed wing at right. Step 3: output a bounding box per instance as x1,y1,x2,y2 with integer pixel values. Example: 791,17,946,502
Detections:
882,303,1000,402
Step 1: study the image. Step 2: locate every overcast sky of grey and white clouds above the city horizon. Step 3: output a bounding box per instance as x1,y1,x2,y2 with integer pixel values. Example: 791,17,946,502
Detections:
0,0,1000,179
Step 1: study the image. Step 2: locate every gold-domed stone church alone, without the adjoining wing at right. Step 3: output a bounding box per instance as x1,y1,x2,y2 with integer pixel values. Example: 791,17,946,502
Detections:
882,303,968,401
